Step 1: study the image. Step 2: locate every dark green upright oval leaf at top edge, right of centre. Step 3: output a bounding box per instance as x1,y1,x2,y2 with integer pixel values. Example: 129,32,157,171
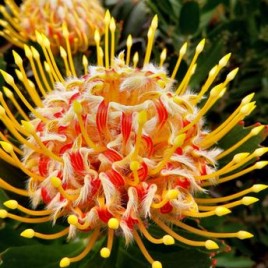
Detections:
179,1,200,35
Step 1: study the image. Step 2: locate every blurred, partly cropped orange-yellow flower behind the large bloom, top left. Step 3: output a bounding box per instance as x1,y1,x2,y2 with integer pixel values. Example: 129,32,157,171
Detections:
0,0,104,53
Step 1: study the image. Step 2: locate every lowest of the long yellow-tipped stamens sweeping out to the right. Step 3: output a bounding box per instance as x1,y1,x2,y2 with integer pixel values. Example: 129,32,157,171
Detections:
152,217,219,250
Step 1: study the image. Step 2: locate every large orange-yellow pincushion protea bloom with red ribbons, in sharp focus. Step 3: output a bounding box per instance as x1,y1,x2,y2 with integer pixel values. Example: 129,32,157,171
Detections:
0,12,268,268
